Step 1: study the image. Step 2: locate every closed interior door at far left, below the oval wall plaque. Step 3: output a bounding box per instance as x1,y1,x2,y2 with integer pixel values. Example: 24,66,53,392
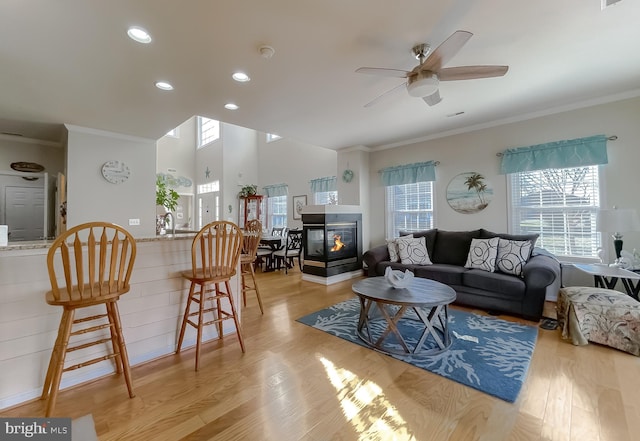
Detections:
4,187,45,241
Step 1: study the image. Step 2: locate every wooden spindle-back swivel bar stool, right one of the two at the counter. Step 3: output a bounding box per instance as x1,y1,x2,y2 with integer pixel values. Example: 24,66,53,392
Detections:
176,221,244,371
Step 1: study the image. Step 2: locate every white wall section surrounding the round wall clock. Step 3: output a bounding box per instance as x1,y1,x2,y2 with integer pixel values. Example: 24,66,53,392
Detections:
66,126,156,237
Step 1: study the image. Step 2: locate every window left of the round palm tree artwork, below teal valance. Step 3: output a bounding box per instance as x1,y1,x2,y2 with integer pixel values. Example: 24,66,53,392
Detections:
386,181,433,237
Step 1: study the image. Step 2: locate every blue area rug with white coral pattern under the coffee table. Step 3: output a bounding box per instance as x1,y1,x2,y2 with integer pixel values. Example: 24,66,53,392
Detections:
297,298,538,403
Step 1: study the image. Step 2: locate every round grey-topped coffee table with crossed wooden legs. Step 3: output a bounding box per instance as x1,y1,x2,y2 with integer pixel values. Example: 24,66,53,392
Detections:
351,277,456,355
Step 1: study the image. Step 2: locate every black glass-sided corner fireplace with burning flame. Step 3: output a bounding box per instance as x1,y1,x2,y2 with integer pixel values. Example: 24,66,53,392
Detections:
302,205,362,277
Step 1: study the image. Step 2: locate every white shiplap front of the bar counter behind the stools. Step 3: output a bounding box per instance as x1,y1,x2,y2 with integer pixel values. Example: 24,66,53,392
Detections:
0,233,242,409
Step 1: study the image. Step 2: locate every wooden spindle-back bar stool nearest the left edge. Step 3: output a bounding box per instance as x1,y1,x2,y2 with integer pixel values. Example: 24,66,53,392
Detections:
41,222,136,417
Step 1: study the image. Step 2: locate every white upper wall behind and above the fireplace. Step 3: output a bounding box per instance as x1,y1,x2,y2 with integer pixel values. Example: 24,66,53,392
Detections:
258,133,338,228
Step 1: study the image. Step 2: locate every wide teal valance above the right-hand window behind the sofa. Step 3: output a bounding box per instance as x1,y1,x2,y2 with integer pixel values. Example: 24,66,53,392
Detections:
500,135,609,175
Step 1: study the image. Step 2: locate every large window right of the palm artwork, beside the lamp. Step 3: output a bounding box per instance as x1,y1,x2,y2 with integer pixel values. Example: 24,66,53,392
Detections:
509,165,600,258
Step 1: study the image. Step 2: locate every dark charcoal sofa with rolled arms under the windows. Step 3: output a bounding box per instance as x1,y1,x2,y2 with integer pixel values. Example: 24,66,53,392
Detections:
363,229,561,321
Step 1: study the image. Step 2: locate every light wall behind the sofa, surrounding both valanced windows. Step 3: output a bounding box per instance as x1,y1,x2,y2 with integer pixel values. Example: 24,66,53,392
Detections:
365,94,640,256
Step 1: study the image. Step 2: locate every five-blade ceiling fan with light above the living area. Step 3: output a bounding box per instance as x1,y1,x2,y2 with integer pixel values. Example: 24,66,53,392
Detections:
356,31,509,107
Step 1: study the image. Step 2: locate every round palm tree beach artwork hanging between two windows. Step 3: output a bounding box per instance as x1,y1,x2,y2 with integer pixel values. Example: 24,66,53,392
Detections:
447,172,493,214
